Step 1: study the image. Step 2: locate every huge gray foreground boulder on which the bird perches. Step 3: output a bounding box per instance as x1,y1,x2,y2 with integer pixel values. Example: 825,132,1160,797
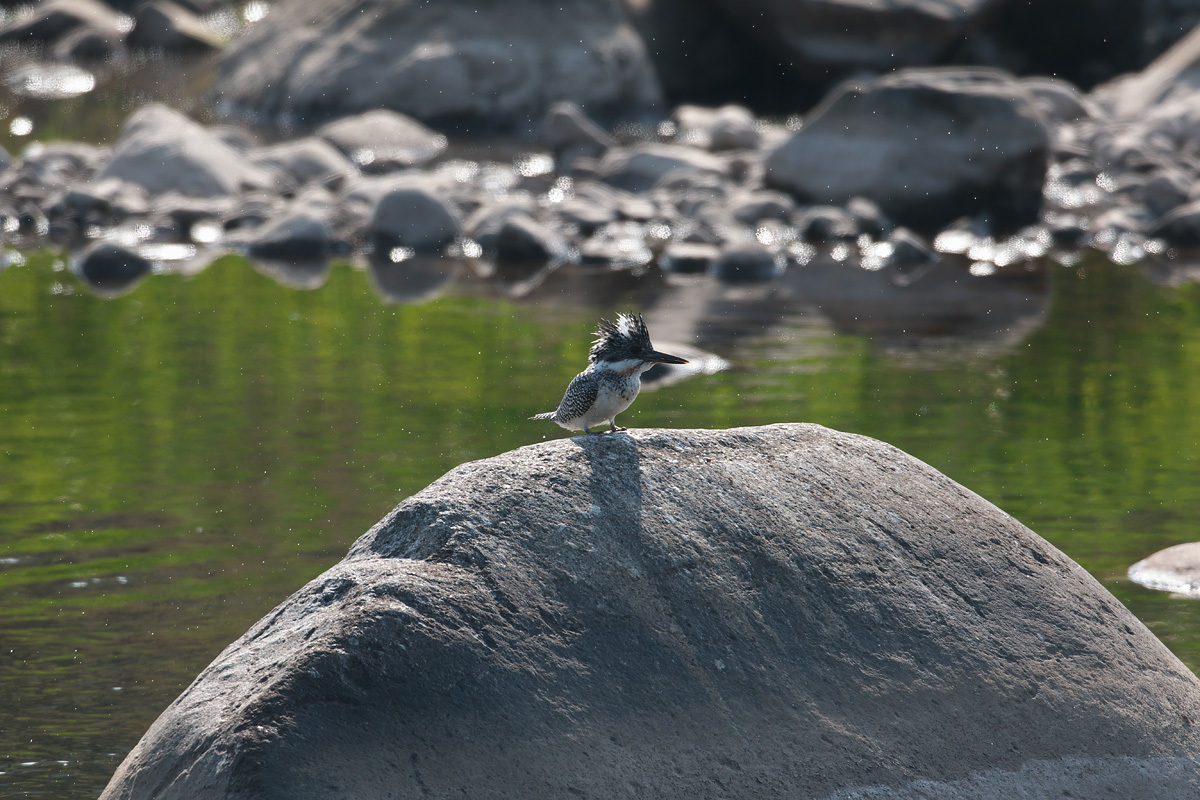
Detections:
102,425,1200,800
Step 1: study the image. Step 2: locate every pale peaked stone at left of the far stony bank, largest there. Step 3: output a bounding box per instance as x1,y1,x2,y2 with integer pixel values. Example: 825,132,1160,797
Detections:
100,103,275,198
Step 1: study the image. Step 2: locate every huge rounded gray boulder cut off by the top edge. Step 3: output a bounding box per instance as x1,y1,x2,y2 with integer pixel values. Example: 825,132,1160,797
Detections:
215,0,660,130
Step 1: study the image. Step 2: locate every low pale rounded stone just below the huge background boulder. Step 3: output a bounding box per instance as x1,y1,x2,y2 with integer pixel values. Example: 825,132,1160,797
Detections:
317,108,446,172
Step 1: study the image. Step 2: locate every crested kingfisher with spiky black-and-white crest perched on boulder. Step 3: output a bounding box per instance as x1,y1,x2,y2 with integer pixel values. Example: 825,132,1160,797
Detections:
529,314,688,434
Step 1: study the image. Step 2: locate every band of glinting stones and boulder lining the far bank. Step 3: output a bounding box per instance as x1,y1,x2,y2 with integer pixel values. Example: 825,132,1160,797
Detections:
7,53,1200,296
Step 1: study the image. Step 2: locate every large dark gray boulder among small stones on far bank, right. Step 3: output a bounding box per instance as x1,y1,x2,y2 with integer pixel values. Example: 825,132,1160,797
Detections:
764,70,1050,229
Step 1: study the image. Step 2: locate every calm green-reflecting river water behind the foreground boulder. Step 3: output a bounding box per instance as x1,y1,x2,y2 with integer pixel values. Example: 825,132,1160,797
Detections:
0,248,1200,796
